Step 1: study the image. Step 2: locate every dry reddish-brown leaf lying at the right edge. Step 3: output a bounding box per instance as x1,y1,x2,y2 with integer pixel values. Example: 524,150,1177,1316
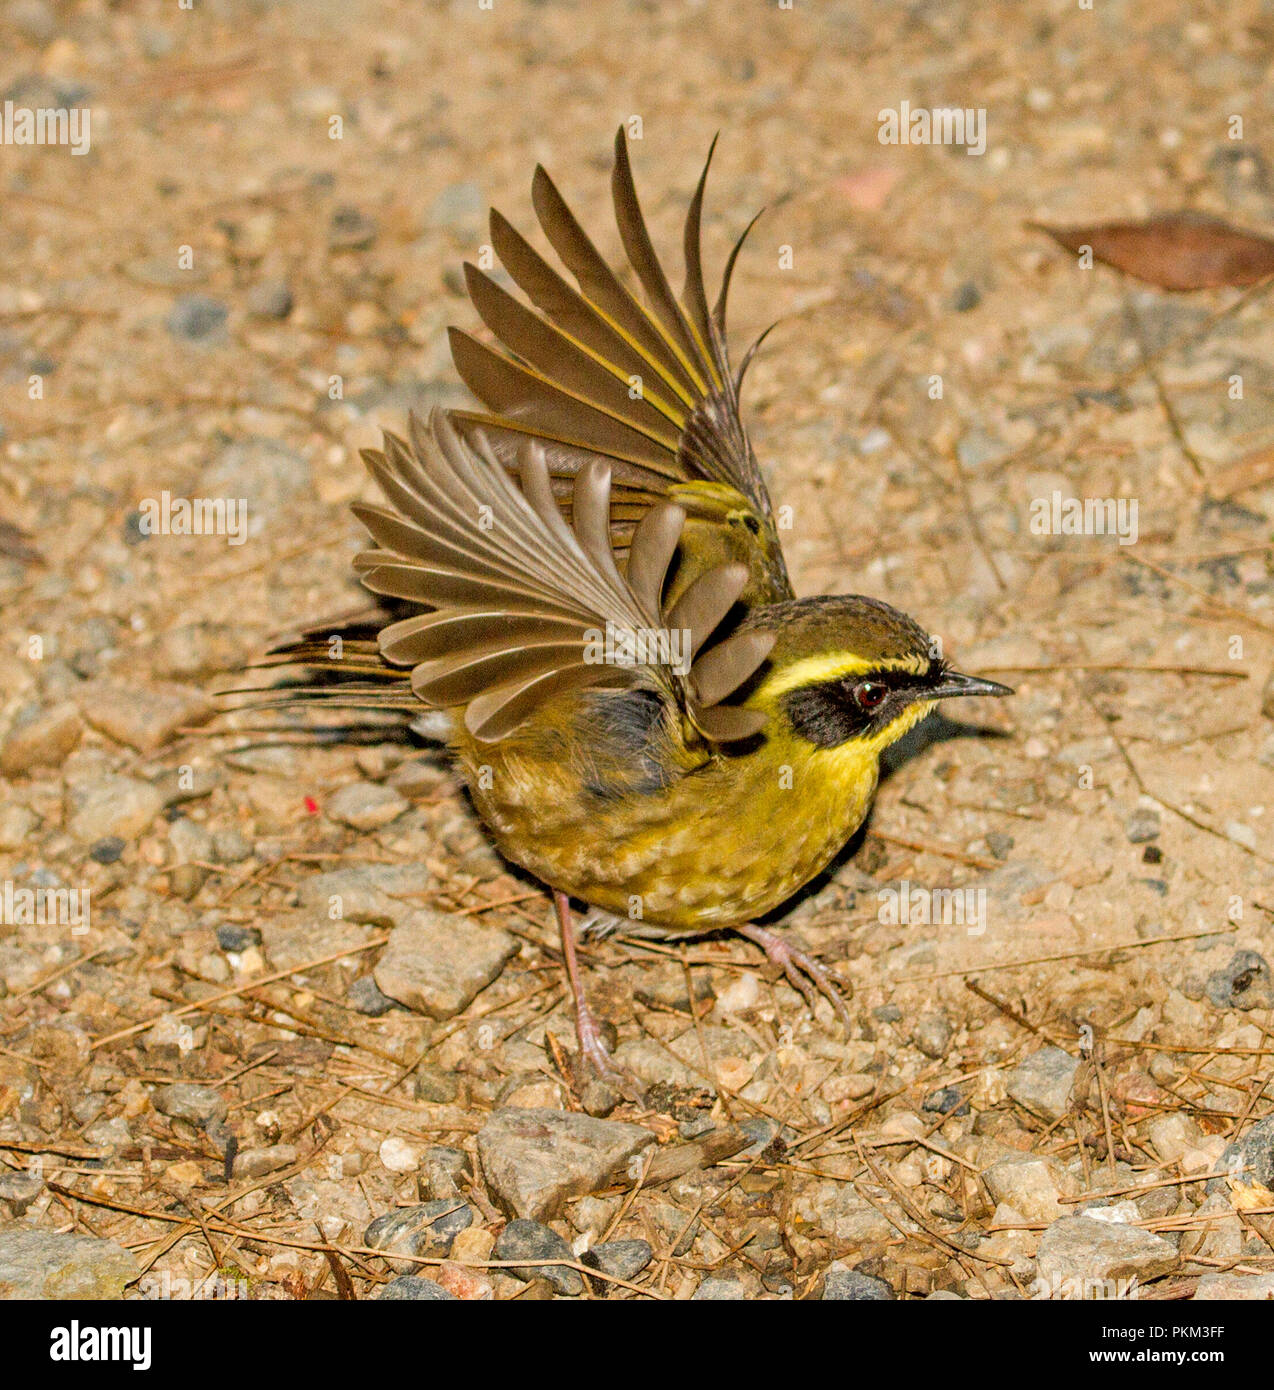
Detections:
1031,213,1274,291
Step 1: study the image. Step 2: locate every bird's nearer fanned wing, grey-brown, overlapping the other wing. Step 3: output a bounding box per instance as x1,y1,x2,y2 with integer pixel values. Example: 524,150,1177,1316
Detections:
343,413,774,741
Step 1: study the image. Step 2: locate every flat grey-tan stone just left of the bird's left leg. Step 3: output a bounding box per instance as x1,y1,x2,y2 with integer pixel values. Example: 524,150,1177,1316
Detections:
375,909,518,1019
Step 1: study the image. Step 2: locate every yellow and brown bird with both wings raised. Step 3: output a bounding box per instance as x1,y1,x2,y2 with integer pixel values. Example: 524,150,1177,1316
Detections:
255,126,1013,1079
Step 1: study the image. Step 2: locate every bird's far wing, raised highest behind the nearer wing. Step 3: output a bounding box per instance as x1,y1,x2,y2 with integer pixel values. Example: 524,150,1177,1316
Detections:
450,128,792,603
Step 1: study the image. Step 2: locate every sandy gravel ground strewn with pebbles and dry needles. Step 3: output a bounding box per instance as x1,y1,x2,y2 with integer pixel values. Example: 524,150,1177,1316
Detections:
0,0,1274,1300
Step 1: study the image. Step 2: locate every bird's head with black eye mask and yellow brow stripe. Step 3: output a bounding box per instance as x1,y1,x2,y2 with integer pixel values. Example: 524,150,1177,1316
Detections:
746,595,1013,758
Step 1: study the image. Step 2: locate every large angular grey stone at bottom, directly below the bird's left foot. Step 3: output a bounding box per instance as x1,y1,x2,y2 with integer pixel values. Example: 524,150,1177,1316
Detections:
478,1109,654,1220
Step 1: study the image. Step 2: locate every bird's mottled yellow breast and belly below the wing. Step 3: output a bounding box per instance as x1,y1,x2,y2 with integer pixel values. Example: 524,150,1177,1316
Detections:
456,706,878,931
